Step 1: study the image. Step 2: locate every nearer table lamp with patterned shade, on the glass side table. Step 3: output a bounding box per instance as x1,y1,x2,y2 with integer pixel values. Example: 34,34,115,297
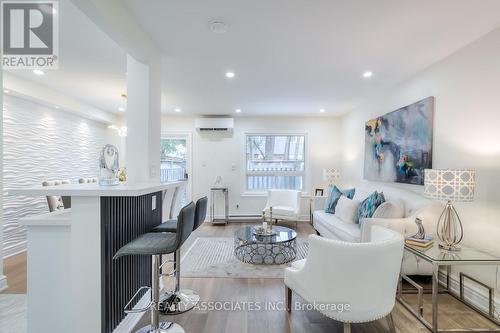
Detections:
424,169,476,251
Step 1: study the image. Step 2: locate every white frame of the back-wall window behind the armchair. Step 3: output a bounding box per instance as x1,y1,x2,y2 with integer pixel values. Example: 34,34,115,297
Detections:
242,132,311,197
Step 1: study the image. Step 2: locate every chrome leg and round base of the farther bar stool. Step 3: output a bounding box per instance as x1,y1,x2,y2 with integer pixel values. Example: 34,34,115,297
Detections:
160,249,200,315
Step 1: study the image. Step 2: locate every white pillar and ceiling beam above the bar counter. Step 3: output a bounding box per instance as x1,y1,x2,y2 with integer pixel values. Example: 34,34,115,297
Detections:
72,0,162,182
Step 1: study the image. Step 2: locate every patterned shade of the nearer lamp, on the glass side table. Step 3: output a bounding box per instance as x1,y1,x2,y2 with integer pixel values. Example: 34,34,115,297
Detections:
424,169,476,202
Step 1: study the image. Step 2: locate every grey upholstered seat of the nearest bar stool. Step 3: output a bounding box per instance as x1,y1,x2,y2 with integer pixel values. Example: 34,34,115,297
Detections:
114,231,178,259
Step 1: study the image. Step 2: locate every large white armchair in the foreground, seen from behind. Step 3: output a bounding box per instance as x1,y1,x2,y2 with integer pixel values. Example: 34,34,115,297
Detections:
285,226,403,332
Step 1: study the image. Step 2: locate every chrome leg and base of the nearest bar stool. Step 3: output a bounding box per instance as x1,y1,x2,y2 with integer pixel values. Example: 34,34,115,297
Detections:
136,255,185,333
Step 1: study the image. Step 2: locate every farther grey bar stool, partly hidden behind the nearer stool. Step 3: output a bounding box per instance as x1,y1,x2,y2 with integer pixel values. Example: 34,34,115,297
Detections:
152,197,208,315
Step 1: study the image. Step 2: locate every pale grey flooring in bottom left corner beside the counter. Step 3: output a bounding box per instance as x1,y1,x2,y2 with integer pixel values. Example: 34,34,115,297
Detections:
0,294,27,333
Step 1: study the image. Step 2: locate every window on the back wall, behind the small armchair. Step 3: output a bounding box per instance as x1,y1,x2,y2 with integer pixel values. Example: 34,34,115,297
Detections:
246,134,306,191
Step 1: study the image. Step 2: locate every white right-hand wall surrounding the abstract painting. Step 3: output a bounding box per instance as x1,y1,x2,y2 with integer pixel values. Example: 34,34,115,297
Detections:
341,30,500,285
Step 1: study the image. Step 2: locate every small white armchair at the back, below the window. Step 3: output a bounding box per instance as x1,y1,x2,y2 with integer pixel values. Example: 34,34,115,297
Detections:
263,190,300,226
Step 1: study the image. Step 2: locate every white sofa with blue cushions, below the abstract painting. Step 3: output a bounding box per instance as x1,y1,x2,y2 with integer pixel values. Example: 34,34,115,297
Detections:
313,184,442,275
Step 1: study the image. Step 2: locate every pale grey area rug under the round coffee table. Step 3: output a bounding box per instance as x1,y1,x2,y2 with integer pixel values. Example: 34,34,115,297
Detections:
181,237,309,279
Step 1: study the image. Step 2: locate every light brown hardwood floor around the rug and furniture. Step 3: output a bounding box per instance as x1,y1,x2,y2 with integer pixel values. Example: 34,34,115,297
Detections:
4,219,495,333
